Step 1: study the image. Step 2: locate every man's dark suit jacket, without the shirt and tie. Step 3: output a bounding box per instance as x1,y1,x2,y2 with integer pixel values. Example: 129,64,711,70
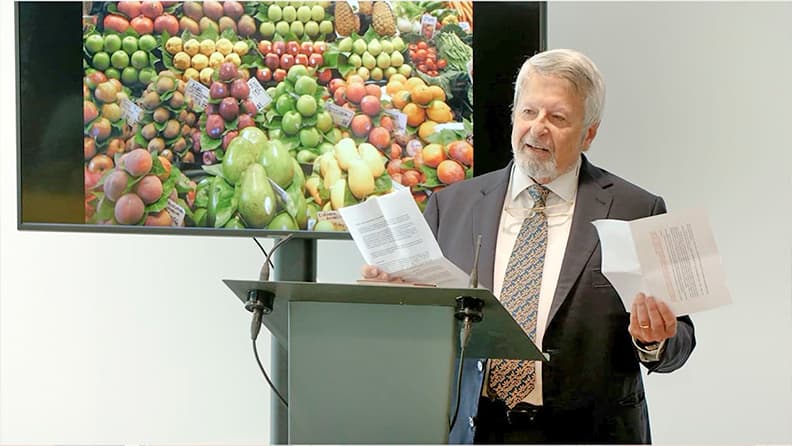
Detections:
424,156,695,444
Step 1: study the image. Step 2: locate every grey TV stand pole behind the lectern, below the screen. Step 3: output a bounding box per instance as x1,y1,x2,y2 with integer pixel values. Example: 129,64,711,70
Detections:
270,238,317,444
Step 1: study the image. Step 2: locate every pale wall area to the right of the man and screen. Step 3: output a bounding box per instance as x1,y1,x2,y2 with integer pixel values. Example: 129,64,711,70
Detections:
548,2,792,444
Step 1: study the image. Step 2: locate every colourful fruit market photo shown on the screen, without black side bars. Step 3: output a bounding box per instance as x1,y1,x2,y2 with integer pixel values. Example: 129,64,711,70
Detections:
82,0,474,232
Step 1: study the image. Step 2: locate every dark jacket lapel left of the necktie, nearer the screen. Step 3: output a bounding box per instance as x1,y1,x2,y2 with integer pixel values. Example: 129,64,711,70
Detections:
471,163,512,290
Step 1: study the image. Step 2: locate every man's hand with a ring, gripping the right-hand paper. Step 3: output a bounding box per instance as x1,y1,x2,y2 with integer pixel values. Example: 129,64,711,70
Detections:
627,293,677,344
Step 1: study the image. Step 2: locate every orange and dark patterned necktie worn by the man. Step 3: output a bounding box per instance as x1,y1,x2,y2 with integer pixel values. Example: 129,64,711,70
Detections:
489,184,549,408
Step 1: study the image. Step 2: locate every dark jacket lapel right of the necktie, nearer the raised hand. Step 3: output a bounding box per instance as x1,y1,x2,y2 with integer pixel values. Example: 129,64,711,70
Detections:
547,159,613,327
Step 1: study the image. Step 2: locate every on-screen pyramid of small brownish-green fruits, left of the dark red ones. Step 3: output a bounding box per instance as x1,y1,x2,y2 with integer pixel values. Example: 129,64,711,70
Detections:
133,71,196,163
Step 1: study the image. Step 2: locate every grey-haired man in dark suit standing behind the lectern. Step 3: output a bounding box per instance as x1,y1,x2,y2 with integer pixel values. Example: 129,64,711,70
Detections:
364,50,695,444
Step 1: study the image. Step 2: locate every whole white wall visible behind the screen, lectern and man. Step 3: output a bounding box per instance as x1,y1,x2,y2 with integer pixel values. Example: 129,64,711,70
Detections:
0,3,792,444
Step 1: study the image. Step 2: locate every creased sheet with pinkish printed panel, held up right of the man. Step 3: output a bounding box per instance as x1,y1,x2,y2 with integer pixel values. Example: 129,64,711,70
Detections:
592,210,731,316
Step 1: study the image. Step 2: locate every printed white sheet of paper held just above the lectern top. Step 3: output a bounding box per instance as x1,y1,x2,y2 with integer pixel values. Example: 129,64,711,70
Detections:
339,189,472,288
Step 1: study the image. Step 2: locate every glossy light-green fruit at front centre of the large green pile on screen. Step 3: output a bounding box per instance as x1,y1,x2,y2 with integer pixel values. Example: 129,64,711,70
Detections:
238,163,277,228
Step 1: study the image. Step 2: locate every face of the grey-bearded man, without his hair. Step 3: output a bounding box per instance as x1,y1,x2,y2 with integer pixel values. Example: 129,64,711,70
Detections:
511,73,598,184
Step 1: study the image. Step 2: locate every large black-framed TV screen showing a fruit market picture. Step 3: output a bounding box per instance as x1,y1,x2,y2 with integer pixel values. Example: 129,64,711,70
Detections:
15,0,545,238
